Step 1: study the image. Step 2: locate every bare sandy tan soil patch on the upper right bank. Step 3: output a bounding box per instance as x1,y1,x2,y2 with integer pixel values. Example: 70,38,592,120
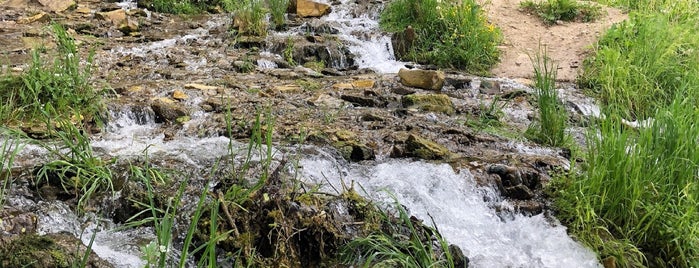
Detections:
483,0,628,81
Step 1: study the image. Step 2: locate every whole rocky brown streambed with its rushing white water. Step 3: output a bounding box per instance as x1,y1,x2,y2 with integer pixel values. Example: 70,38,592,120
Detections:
0,0,599,267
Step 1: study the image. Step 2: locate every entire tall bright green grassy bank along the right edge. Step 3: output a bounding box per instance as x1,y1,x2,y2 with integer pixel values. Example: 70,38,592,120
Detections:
554,1,699,267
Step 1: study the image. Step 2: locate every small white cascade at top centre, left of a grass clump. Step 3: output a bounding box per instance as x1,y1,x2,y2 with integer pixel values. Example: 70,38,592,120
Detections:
321,0,405,73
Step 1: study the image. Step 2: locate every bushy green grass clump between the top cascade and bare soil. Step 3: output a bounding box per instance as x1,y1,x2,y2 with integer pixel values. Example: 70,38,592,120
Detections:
380,0,502,74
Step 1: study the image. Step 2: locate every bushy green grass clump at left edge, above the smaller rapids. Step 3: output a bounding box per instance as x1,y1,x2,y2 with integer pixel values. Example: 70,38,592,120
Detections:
0,24,104,126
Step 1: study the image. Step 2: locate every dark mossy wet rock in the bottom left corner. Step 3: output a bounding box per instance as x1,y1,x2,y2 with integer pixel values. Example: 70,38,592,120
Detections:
0,233,114,268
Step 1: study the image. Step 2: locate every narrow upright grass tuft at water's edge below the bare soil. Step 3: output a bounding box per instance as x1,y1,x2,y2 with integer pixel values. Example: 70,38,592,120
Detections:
527,50,569,146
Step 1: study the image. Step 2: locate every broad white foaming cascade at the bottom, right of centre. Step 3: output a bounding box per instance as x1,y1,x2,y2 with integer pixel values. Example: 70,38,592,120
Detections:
301,152,601,268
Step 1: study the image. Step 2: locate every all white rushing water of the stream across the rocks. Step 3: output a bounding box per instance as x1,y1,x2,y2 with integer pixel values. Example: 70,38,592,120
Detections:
0,0,601,267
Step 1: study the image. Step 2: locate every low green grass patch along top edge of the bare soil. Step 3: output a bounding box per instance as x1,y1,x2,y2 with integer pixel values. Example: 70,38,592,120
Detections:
519,0,602,25
